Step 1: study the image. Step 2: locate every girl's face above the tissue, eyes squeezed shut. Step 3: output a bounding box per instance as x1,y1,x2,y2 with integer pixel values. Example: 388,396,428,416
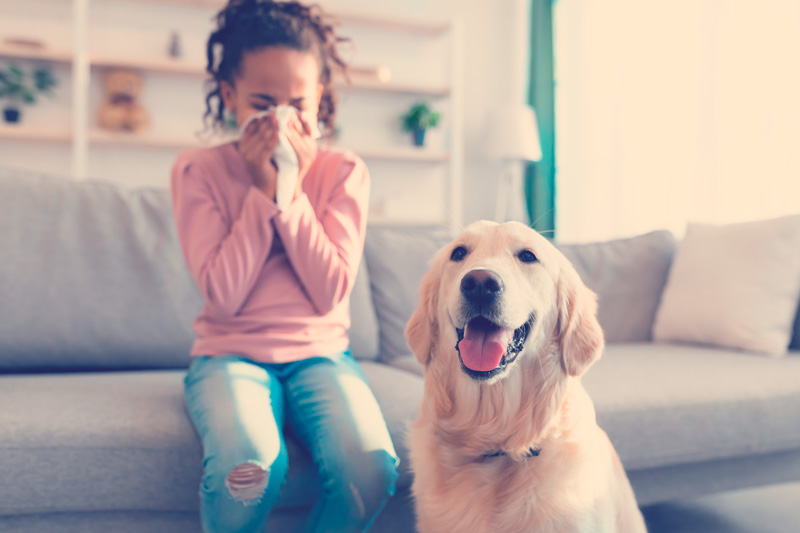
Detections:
220,46,324,127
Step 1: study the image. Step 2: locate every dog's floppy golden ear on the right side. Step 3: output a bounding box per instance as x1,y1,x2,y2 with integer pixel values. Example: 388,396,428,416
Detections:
557,263,605,376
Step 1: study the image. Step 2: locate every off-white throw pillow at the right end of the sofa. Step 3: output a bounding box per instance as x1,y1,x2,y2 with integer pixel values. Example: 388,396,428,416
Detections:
653,215,800,356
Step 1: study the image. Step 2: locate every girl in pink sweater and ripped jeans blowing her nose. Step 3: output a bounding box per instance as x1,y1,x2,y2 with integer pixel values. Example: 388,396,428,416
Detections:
172,0,398,532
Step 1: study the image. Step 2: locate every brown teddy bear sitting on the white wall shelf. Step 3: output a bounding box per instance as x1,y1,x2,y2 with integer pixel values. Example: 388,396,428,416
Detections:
97,70,150,132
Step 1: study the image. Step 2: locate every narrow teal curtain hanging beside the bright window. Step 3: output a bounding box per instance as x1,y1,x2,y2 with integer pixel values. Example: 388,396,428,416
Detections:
525,0,556,238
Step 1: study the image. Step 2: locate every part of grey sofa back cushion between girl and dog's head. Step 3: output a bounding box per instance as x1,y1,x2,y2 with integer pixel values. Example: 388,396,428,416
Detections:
364,226,453,362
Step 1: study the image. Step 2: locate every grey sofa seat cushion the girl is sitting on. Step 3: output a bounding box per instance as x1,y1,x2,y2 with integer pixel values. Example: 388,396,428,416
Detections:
0,361,422,515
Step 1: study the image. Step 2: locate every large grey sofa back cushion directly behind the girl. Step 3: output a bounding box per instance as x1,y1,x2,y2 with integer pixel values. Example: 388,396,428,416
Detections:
0,169,378,372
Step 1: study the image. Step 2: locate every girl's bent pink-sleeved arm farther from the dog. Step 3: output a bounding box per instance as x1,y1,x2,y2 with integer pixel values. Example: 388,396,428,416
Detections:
172,156,278,317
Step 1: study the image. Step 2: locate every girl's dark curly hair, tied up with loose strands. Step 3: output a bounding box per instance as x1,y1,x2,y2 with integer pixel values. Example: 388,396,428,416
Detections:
203,0,349,133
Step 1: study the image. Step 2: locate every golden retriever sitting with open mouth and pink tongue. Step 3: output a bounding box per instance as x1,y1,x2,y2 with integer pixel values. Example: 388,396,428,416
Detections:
405,221,646,533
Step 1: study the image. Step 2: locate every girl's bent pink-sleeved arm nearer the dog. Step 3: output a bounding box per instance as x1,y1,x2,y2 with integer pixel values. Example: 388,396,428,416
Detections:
273,152,369,314
